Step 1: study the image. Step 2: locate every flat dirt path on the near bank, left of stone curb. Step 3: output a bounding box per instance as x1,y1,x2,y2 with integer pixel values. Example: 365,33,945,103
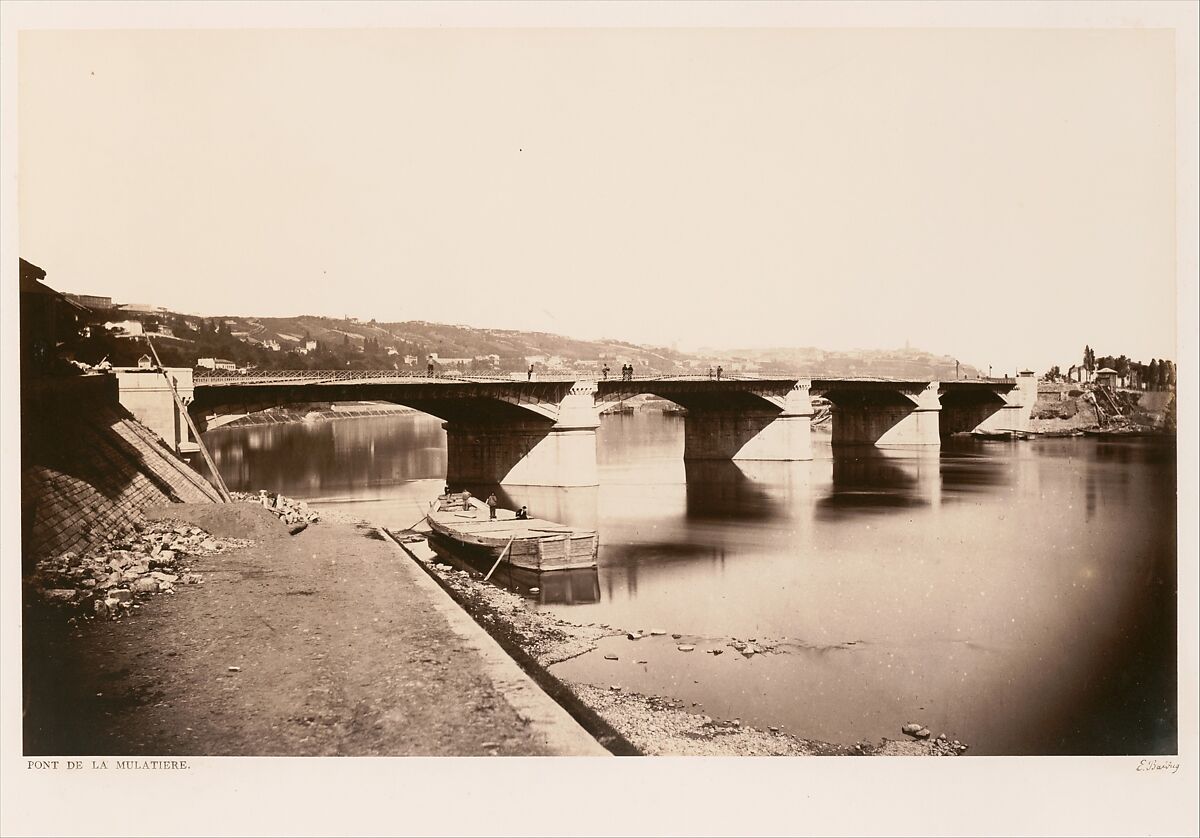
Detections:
25,508,609,755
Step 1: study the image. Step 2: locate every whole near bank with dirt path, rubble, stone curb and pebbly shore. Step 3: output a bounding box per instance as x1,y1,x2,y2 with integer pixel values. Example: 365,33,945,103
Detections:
24,489,960,756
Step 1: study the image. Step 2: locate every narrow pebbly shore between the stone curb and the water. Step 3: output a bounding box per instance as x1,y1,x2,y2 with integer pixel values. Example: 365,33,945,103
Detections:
388,531,967,756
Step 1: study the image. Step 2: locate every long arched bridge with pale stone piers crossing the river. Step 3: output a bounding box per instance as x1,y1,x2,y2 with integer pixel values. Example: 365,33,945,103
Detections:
174,370,1037,486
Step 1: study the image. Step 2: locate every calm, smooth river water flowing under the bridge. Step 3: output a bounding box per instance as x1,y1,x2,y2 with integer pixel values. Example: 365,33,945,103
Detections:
205,413,1176,755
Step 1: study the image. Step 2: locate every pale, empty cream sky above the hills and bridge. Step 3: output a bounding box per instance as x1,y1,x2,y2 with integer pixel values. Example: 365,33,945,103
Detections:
19,29,1176,371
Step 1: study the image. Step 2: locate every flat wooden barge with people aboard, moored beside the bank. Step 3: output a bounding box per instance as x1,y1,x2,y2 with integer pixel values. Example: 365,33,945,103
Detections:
428,492,600,573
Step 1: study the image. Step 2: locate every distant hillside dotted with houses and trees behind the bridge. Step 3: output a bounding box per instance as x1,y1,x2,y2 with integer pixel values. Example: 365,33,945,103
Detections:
71,298,977,378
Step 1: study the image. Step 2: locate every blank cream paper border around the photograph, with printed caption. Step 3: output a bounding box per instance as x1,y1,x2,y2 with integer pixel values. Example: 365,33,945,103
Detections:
0,2,1200,836
